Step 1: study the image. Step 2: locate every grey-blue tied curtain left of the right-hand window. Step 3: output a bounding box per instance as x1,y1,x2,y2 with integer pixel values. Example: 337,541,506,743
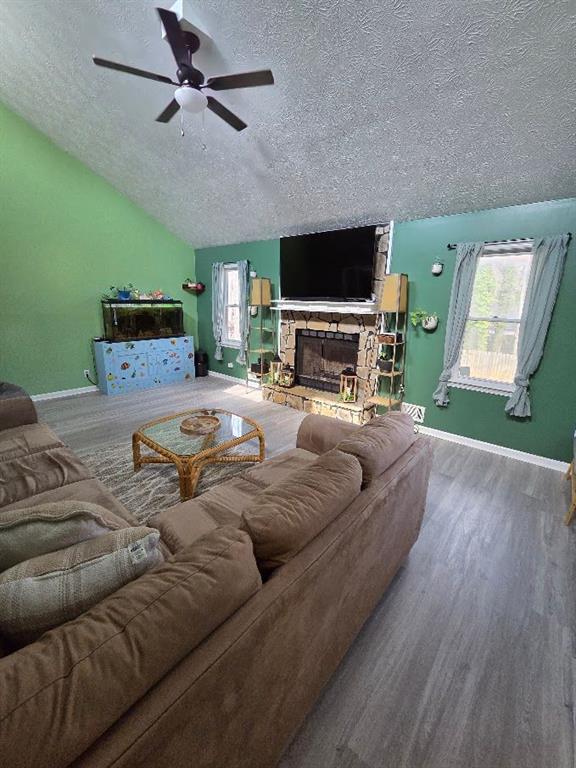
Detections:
432,243,484,407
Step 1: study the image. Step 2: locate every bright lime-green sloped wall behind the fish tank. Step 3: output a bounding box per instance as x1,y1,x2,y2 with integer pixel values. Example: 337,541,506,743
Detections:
0,105,196,394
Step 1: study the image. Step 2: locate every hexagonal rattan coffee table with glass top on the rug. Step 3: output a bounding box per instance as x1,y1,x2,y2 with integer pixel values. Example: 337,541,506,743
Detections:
132,408,265,501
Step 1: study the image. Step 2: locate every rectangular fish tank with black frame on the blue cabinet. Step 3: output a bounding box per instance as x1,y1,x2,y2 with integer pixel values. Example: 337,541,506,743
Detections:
102,299,184,341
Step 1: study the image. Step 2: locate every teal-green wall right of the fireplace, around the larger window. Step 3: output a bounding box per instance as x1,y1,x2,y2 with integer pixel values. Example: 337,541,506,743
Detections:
392,198,576,461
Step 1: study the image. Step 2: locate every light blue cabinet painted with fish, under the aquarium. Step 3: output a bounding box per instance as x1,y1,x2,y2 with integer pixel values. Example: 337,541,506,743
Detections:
94,336,194,395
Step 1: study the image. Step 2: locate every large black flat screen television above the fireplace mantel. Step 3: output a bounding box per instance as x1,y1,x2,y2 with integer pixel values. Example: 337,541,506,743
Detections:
280,227,376,301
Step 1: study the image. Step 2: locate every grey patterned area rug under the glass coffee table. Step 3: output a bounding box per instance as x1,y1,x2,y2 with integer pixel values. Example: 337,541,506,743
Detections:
81,440,258,523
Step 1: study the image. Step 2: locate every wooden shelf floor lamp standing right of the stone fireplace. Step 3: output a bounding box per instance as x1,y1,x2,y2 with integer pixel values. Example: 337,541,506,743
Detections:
367,274,408,411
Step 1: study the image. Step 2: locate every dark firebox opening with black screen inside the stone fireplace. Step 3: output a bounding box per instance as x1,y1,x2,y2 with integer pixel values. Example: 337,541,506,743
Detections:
294,328,360,392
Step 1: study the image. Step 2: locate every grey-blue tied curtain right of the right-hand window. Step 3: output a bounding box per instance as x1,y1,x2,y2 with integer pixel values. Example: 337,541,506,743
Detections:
505,235,570,418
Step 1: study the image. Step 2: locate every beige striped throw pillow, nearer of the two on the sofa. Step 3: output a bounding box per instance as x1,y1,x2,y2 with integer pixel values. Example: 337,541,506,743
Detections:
0,527,164,644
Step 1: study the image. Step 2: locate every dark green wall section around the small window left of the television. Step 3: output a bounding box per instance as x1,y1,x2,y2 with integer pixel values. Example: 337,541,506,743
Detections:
196,240,280,379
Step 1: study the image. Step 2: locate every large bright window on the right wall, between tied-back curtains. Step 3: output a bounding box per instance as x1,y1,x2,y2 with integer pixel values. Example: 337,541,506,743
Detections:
450,241,532,394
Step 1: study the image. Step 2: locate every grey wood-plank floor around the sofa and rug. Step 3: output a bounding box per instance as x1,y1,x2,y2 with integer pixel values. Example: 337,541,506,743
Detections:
39,379,576,768
